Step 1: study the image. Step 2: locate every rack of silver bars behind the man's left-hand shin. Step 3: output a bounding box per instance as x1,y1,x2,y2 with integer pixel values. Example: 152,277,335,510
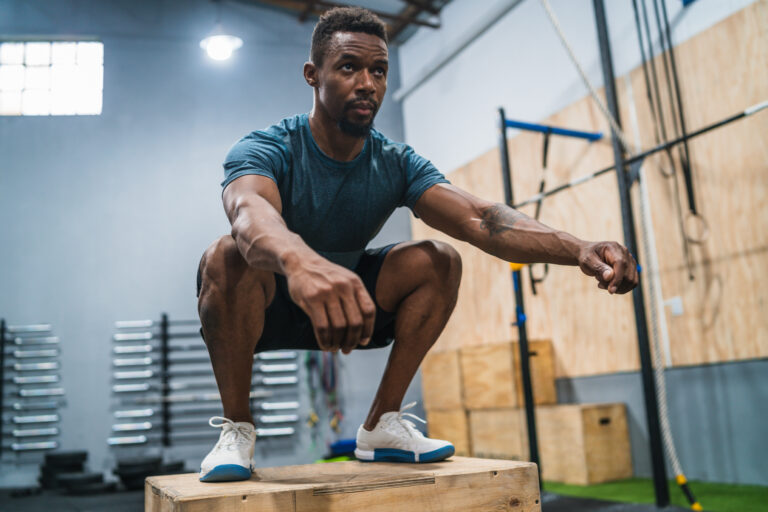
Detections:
108,315,299,450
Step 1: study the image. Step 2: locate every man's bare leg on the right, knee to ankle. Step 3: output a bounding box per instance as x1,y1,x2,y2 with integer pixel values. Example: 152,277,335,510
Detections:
363,240,461,431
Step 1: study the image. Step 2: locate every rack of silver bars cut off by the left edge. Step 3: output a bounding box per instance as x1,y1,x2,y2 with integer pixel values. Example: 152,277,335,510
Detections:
0,321,64,460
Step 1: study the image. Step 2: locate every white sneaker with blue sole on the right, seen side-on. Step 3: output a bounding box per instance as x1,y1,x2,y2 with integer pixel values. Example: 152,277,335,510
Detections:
355,402,455,462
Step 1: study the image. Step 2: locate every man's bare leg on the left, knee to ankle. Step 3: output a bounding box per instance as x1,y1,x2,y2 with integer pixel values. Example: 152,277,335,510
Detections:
198,235,275,423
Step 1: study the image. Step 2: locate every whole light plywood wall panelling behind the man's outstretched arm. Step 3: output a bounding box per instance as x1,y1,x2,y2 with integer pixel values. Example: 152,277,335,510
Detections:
413,1,768,377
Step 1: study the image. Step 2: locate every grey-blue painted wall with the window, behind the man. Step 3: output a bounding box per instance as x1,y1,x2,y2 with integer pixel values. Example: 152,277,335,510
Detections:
0,0,420,488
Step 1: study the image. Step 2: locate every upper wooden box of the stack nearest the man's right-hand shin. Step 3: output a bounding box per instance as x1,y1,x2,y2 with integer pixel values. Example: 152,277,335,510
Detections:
421,350,462,411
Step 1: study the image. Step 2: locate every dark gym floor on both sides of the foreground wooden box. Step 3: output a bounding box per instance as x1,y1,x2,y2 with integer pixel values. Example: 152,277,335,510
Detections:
0,491,686,512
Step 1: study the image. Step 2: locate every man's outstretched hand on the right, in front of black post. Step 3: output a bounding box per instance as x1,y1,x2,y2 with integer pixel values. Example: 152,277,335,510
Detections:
579,242,638,294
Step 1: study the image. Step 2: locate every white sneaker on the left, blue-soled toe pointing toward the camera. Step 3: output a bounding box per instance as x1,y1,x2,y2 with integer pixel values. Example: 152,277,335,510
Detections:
200,416,256,482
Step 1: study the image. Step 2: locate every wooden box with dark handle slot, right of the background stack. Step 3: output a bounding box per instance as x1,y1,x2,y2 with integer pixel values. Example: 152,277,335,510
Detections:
536,404,632,485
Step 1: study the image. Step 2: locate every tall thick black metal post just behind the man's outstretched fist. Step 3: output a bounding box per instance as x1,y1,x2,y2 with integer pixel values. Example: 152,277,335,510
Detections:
593,0,669,507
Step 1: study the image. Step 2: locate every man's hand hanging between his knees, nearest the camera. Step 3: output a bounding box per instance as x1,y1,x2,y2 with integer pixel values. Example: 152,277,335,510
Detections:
286,257,376,354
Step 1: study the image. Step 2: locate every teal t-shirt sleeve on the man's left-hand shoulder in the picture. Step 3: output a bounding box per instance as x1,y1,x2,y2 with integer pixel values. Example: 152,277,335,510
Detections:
221,131,288,190
